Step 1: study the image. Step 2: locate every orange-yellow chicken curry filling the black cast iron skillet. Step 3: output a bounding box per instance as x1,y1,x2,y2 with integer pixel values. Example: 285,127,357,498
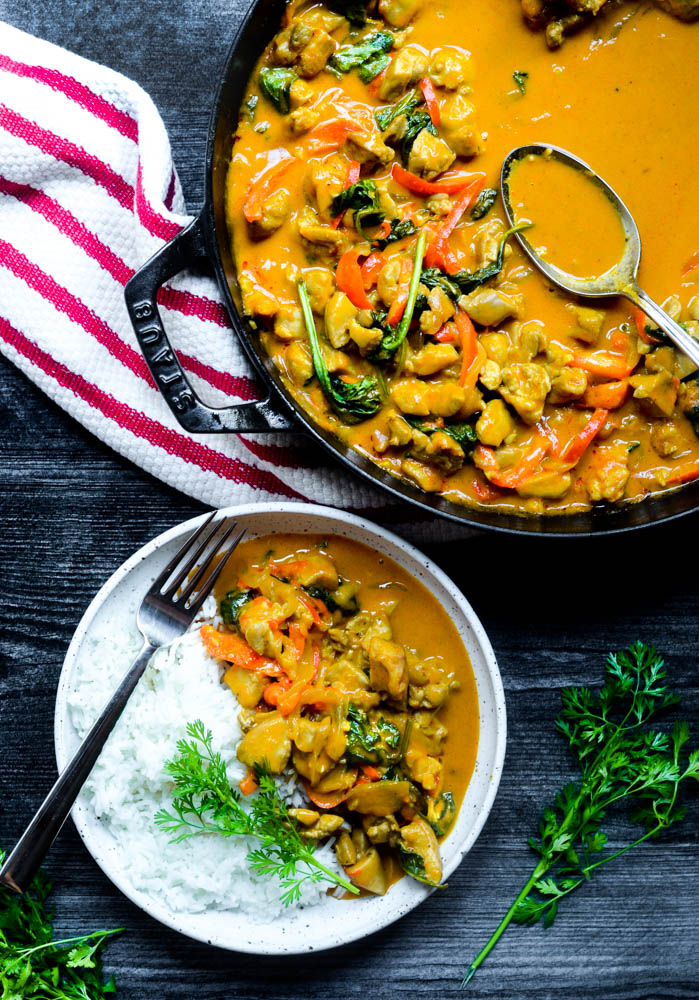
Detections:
227,0,699,514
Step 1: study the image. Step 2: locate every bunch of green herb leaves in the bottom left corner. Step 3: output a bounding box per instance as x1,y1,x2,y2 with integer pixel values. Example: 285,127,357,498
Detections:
0,851,119,1000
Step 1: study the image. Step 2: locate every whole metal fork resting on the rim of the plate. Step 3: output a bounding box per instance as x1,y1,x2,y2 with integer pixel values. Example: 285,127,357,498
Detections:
0,511,245,894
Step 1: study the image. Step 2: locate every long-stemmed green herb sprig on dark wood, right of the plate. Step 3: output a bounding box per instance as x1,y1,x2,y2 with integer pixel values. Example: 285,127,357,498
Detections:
462,642,699,986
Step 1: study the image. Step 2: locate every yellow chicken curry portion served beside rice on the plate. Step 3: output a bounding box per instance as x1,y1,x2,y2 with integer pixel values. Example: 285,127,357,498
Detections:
208,534,479,895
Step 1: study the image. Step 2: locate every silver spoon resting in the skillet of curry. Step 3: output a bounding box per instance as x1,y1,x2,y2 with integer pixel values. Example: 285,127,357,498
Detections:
500,142,699,368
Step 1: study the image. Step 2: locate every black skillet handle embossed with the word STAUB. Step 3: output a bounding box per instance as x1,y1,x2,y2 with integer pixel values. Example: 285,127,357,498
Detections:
124,216,296,434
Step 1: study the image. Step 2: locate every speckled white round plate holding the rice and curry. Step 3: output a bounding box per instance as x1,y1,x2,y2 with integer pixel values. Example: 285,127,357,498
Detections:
55,503,506,955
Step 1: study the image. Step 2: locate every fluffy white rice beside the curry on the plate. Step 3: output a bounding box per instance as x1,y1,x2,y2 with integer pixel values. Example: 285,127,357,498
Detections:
68,598,340,922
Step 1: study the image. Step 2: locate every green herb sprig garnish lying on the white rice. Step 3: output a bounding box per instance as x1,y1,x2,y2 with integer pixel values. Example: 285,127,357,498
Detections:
155,719,358,906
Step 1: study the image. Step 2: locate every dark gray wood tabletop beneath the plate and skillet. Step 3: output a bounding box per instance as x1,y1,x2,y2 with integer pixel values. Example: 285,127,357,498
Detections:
0,0,699,1000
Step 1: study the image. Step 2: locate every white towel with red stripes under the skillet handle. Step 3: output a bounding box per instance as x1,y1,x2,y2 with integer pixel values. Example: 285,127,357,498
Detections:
0,22,474,538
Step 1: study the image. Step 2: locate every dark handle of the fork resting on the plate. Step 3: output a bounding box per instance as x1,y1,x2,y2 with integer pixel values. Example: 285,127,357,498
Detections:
0,642,156,894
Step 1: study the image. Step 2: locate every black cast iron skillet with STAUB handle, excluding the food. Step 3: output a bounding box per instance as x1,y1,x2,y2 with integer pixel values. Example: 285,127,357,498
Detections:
125,0,699,537
